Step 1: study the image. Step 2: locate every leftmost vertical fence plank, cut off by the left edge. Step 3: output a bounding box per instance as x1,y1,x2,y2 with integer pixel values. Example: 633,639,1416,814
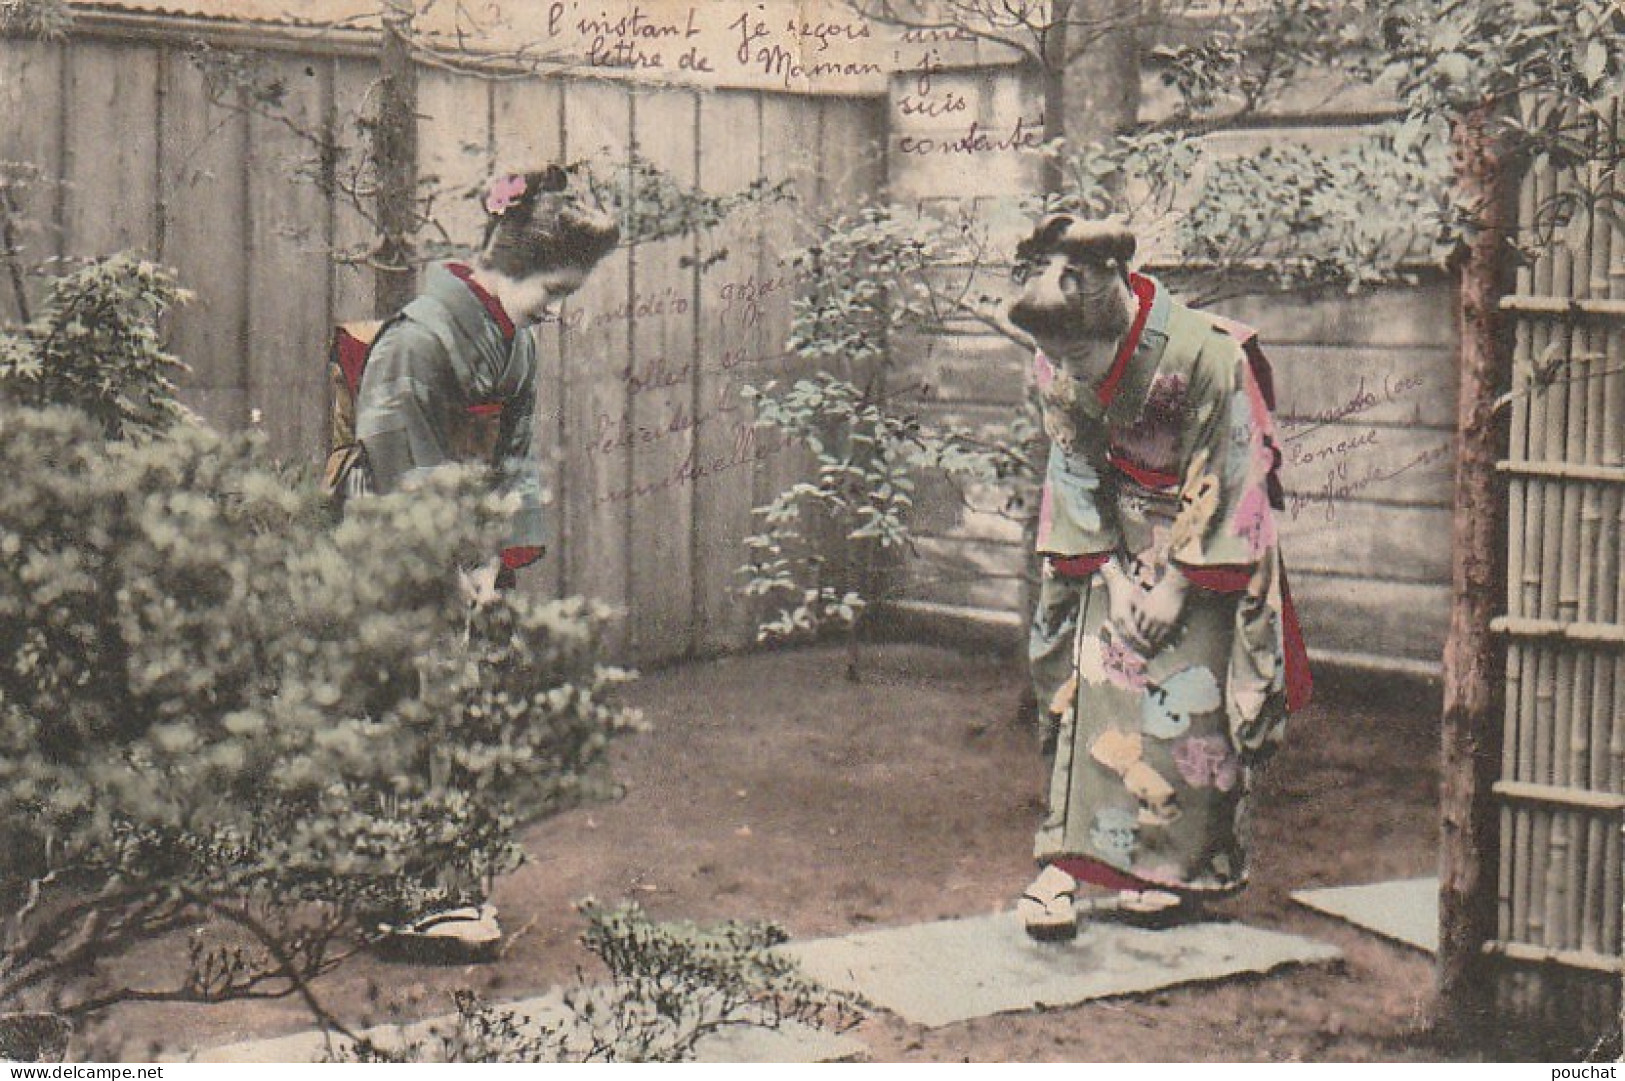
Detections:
0,39,65,322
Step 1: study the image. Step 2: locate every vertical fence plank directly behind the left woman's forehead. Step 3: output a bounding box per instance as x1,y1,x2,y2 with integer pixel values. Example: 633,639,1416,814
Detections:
561,81,634,653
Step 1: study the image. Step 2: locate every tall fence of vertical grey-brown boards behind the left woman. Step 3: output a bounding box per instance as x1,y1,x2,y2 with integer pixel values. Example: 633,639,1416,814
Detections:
0,28,884,662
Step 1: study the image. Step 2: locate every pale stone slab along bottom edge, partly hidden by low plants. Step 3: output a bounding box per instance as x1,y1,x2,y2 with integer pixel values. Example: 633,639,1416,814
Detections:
184,992,866,1063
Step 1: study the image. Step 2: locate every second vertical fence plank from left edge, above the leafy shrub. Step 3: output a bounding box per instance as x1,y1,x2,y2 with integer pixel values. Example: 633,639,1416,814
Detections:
62,41,158,257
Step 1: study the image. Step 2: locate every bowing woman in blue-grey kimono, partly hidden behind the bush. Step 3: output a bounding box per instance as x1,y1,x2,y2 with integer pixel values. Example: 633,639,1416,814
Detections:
338,166,619,961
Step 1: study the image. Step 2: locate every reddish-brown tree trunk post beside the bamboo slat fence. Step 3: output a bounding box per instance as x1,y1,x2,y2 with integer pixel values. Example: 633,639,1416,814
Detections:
1437,101,1515,1042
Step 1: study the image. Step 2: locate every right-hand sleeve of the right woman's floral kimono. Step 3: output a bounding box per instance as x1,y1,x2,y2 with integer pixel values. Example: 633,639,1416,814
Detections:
1168,332,1276,593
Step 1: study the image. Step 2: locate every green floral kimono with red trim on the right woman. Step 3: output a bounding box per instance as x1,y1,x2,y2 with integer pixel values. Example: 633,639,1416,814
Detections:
1032,275,1310,892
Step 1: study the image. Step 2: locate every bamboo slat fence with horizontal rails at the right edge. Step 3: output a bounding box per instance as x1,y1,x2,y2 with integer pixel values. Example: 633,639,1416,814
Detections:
1490,94,1625,1035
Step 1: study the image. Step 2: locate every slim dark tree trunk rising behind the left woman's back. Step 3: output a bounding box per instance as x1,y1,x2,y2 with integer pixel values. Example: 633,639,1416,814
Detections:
372,0,418,319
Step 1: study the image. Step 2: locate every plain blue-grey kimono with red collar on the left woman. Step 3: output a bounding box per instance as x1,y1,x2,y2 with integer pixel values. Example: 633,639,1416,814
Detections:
356,263,546,567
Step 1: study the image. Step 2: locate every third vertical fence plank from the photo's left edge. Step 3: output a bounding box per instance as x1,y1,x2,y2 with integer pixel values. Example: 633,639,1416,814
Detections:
159,50,249,429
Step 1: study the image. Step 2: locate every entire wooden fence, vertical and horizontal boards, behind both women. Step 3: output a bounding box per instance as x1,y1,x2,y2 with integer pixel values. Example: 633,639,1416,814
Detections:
0,16,1454,673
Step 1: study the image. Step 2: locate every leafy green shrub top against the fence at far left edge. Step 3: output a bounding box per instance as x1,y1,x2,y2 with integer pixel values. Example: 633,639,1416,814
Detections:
0,254,189,437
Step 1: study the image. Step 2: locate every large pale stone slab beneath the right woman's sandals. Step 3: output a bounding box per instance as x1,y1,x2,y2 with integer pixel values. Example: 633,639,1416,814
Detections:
780,912,1341,1027
